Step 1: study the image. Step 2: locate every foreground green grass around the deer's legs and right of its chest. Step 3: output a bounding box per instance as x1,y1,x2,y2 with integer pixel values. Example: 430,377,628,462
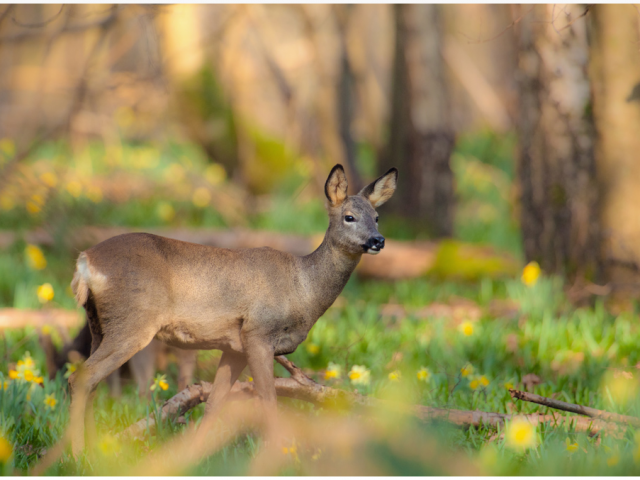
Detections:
0,278,640,475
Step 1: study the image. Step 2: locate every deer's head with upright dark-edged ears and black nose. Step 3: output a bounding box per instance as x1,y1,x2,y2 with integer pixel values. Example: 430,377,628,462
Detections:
324,165,398,255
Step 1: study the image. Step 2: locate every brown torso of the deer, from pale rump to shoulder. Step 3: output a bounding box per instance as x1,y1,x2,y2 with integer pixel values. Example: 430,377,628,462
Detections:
74,233,303,348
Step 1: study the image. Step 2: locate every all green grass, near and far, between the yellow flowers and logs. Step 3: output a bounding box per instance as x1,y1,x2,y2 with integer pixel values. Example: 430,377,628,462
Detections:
0,133,640,475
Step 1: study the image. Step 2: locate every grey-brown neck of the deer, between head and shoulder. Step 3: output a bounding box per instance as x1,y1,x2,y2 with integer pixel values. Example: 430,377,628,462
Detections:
301,231,362,322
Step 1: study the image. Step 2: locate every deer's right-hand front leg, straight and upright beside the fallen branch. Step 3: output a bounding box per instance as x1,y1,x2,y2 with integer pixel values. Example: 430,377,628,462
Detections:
242,334,278,433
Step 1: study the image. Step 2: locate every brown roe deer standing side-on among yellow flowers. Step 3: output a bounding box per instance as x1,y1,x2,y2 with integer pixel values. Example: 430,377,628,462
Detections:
69,165,398,456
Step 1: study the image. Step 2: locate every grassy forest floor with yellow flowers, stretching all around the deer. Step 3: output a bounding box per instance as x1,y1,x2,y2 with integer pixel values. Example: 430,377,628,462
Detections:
0,136,640,475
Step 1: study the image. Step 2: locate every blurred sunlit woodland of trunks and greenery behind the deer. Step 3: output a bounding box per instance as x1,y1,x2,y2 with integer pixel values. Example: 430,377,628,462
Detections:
0,4,640,473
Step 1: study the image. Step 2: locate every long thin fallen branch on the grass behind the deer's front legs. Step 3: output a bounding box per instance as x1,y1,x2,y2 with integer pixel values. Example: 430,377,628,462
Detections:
118,357,621,438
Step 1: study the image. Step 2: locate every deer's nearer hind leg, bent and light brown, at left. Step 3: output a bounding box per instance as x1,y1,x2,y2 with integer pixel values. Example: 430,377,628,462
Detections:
69,316,155,457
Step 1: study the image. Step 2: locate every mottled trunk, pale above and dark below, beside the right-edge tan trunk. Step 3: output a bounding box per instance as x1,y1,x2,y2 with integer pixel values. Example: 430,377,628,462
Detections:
517,5,601,280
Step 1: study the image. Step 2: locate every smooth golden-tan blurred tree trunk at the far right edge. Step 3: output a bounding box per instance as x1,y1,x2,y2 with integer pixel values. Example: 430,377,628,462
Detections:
590,5,640,300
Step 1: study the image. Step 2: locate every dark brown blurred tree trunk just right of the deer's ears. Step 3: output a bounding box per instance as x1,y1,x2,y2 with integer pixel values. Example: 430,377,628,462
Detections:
382,5,455,237
